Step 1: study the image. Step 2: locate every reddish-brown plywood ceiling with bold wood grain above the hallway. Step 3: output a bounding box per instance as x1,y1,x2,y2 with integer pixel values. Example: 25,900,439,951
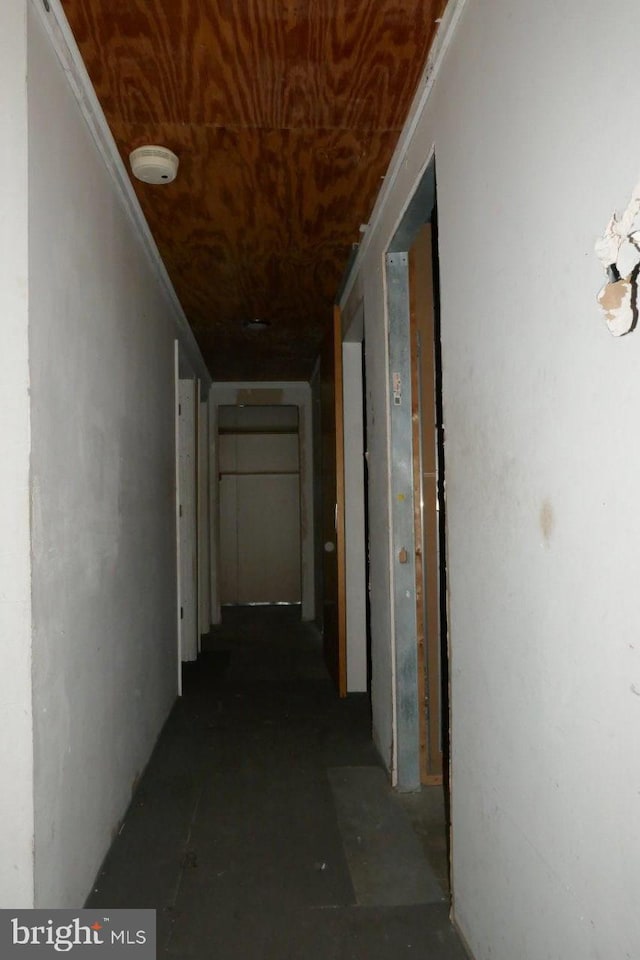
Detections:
63,0,446,380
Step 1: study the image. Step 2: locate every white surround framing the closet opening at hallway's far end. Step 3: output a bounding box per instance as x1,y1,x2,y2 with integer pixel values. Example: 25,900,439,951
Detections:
209,381,315,620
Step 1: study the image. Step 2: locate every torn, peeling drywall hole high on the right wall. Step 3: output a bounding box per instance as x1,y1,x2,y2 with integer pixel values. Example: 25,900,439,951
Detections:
595,181,640,337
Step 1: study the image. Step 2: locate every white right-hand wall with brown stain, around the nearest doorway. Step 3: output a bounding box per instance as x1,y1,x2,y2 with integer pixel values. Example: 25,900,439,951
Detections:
347,0,640,960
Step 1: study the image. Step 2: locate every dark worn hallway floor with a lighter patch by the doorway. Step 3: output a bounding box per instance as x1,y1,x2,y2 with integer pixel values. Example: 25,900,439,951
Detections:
87,607,466,960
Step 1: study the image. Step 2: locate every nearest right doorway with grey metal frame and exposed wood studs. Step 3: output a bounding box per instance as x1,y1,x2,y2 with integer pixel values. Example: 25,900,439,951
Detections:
386,157,450,884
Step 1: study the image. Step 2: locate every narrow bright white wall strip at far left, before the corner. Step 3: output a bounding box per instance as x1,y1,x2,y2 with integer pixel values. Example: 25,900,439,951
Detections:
0,0,33,907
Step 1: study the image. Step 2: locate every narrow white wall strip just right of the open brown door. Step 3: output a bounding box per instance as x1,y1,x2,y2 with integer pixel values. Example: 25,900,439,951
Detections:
342,343,367,693
